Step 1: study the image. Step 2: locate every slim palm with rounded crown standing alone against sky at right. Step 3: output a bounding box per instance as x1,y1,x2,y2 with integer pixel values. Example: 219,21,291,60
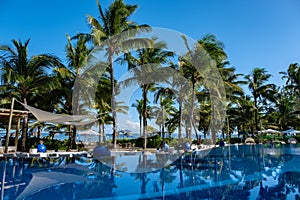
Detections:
245,68,276,131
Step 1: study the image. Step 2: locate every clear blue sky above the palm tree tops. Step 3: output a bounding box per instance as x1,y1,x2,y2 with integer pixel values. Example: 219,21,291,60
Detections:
0,0,300,133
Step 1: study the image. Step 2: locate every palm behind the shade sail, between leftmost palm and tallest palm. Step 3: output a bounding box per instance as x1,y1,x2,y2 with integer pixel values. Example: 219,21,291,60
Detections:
54,35,95,148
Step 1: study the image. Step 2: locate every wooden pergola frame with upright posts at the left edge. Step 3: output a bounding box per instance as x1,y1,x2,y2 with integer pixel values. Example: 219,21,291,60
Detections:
0,98,29,153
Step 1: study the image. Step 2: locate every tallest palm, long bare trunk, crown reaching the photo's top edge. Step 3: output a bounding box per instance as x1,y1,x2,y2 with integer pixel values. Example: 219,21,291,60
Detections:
88,0,150,148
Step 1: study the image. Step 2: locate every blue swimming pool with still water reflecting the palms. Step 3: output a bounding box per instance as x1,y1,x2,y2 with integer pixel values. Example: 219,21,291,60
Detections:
0,145,300,200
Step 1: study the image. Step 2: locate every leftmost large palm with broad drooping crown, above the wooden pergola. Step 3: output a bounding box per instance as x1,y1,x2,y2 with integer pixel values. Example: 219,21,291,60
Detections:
0,39,61,151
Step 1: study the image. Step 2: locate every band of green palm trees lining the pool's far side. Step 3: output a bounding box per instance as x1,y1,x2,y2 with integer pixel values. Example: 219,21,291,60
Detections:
0,0,300,151
